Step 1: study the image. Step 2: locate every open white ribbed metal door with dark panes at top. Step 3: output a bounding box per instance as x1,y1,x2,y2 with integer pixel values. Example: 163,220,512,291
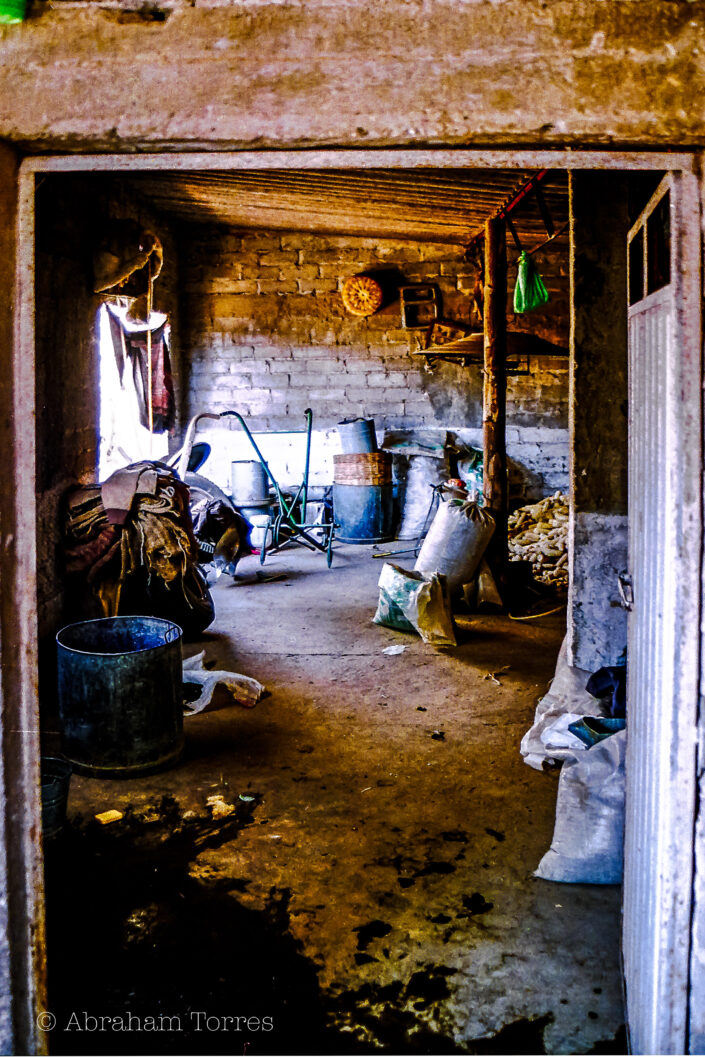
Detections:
623,174,702,1054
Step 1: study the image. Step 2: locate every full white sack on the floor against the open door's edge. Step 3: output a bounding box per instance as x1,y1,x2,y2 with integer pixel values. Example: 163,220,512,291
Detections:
535,730,627,885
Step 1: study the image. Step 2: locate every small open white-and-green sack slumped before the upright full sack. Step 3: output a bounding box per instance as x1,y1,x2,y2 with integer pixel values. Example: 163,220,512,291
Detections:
372,561,458,646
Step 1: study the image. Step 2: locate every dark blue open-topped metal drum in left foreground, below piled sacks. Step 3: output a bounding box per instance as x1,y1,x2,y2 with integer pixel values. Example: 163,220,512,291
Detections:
56,616,184,778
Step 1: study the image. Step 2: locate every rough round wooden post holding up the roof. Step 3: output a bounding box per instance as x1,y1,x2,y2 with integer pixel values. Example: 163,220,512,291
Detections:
482,219,507,579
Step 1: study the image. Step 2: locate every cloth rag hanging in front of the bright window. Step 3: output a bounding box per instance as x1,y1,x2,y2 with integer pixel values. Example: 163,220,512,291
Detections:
108,310,175,433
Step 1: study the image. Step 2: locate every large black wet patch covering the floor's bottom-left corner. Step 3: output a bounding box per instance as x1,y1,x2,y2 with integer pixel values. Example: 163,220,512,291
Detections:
47,798,342,1055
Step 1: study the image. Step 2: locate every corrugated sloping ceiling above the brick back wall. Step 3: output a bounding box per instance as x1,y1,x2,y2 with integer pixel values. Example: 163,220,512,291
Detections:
129,169,569,245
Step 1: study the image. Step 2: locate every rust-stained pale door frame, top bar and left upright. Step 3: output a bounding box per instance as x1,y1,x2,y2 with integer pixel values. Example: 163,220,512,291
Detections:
0,148,702,1053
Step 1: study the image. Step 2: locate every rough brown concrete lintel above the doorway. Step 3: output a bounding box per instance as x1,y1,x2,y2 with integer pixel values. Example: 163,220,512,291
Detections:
0,0,705,150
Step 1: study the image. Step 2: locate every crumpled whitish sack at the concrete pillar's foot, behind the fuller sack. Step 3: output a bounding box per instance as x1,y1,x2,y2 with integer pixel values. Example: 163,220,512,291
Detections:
521,638,606,771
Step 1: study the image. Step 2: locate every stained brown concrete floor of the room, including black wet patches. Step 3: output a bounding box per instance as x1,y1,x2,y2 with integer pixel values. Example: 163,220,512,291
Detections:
47,546,626,1055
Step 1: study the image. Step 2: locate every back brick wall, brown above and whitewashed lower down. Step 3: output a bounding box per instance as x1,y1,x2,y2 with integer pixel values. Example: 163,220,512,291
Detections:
180,227,569,503
